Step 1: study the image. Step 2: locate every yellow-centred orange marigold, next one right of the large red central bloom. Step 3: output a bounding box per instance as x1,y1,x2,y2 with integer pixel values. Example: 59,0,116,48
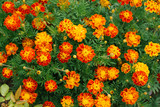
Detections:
107,45,121,59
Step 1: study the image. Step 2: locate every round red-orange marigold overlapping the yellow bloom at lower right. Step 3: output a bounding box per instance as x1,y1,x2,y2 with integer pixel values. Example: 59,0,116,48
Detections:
132,71,148,86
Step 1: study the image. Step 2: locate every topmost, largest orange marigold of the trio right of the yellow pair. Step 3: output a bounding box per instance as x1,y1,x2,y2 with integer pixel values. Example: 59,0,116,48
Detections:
89,14,106,29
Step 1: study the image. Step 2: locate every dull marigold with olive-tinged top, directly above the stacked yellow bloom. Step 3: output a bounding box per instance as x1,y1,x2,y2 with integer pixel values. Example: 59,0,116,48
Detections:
32,18,46,31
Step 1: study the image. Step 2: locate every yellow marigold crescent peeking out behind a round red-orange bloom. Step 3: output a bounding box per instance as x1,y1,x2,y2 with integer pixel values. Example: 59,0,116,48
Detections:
133,62,150,76
